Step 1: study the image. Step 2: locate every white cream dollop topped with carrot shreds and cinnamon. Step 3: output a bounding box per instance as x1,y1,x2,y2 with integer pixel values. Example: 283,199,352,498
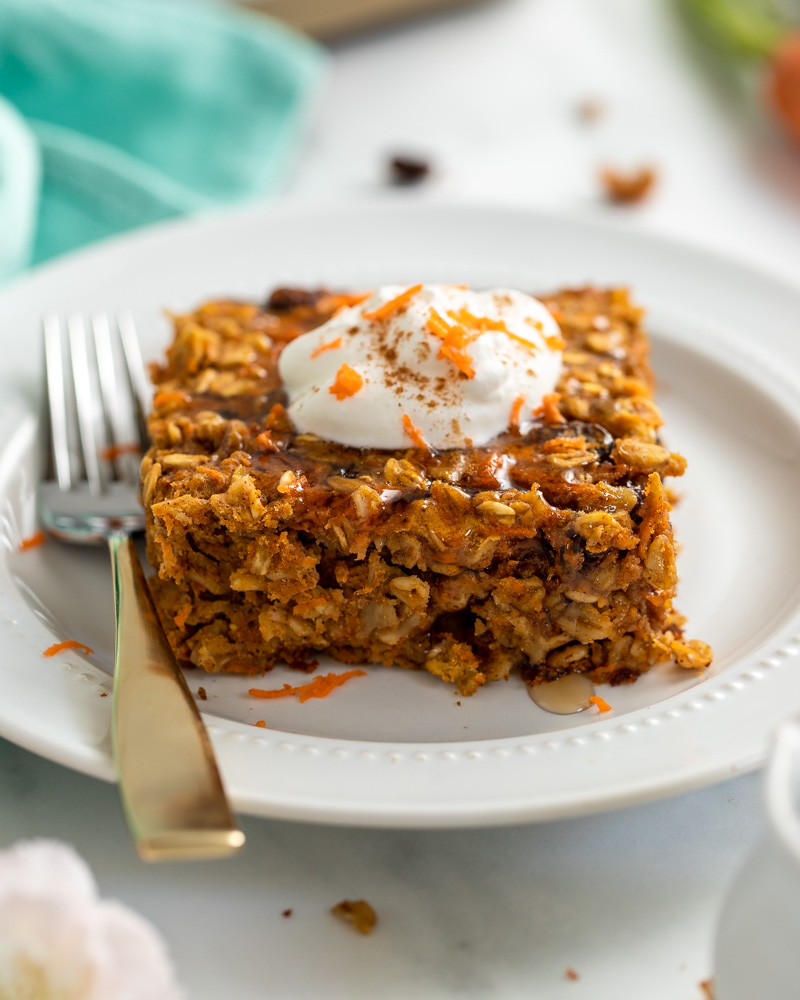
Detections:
279,285,563,449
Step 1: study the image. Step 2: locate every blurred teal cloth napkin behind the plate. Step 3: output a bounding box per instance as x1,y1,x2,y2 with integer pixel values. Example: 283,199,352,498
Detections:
0,0,324,278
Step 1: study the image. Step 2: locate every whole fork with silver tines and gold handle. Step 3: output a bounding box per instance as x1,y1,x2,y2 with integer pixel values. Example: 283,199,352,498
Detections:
38,316,244,861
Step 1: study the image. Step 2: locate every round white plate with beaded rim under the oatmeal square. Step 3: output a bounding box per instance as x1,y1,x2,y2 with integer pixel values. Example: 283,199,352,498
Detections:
0,201,800,826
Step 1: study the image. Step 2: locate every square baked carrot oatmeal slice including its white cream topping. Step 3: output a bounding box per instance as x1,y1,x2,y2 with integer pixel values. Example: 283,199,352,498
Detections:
142,285,711,694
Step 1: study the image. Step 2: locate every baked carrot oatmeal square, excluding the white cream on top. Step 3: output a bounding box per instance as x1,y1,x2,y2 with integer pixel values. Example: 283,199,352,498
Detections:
142,288,711,694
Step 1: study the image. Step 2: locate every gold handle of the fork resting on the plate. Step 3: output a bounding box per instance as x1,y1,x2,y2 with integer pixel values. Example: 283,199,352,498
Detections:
108,532,244,861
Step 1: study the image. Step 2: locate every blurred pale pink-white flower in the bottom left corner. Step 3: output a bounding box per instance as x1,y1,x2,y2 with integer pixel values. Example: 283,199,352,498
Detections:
0,840,183,1000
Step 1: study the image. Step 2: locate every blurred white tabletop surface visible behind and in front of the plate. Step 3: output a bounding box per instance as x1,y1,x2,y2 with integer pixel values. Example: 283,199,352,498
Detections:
0,0,800,1000
